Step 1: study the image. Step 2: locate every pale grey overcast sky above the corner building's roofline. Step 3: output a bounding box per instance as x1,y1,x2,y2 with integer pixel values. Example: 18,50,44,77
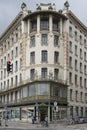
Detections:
0,0,87,35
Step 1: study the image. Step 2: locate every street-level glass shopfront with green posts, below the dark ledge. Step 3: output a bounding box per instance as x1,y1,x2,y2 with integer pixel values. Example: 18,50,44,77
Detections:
0,103,67,122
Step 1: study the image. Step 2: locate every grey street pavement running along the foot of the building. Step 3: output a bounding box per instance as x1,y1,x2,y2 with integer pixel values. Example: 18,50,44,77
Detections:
0,120,87,130
